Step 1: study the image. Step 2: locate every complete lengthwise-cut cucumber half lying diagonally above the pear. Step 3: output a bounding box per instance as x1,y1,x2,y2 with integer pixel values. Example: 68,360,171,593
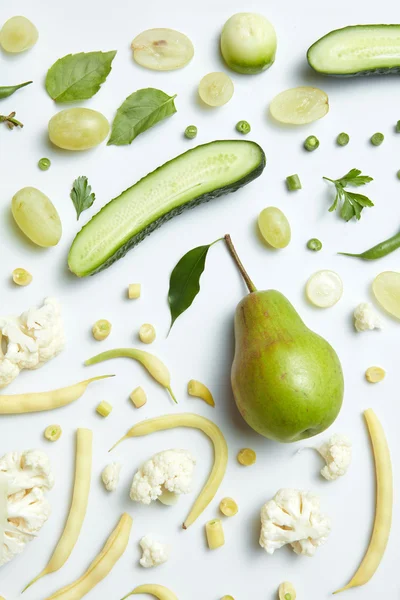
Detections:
68,140,265,277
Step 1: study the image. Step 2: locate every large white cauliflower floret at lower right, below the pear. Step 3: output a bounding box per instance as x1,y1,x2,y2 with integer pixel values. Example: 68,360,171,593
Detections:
260,488,331,556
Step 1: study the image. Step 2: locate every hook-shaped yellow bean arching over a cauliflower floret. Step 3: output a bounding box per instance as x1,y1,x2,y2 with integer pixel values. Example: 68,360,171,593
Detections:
110,413,228,529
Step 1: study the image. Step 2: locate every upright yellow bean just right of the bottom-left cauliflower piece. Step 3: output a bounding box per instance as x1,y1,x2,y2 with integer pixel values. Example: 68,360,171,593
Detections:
23,429,93,591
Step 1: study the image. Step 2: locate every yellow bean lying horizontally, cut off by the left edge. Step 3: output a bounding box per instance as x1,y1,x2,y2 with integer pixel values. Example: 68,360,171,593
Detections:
0,375,114,415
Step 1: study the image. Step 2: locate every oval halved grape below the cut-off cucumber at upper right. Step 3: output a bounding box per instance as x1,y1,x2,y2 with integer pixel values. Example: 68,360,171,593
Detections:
269,87,329,125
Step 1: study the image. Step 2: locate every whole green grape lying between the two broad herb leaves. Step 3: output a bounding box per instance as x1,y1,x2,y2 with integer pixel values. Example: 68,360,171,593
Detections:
49,108,110,150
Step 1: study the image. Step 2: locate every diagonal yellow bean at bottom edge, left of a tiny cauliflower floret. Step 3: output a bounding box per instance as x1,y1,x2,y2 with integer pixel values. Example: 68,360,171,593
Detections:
46,513,132,600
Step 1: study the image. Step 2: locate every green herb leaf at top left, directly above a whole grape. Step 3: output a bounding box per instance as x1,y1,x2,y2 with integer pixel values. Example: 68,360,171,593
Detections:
46,50,117,102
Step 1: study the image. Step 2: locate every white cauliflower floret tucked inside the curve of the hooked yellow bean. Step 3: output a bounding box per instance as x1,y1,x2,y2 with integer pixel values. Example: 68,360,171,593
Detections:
130,450,196,504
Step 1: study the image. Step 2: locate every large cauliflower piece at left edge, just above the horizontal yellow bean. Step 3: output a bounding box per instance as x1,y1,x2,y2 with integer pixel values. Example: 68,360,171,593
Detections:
0,298,65,388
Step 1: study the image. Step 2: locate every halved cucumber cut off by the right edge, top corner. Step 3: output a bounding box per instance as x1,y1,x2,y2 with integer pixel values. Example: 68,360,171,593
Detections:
307,25,400,77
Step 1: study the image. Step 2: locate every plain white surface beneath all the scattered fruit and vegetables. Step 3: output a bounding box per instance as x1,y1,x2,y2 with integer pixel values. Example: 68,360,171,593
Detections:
0,0,400,600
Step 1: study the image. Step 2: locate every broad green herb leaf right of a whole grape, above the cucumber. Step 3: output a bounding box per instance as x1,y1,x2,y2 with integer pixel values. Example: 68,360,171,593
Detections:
108,88,176,146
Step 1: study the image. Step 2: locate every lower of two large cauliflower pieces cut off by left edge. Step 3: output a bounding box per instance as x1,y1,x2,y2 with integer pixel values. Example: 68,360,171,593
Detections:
0,450,54,566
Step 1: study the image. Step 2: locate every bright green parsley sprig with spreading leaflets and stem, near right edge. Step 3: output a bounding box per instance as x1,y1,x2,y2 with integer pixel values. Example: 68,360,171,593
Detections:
323,169,374,221
